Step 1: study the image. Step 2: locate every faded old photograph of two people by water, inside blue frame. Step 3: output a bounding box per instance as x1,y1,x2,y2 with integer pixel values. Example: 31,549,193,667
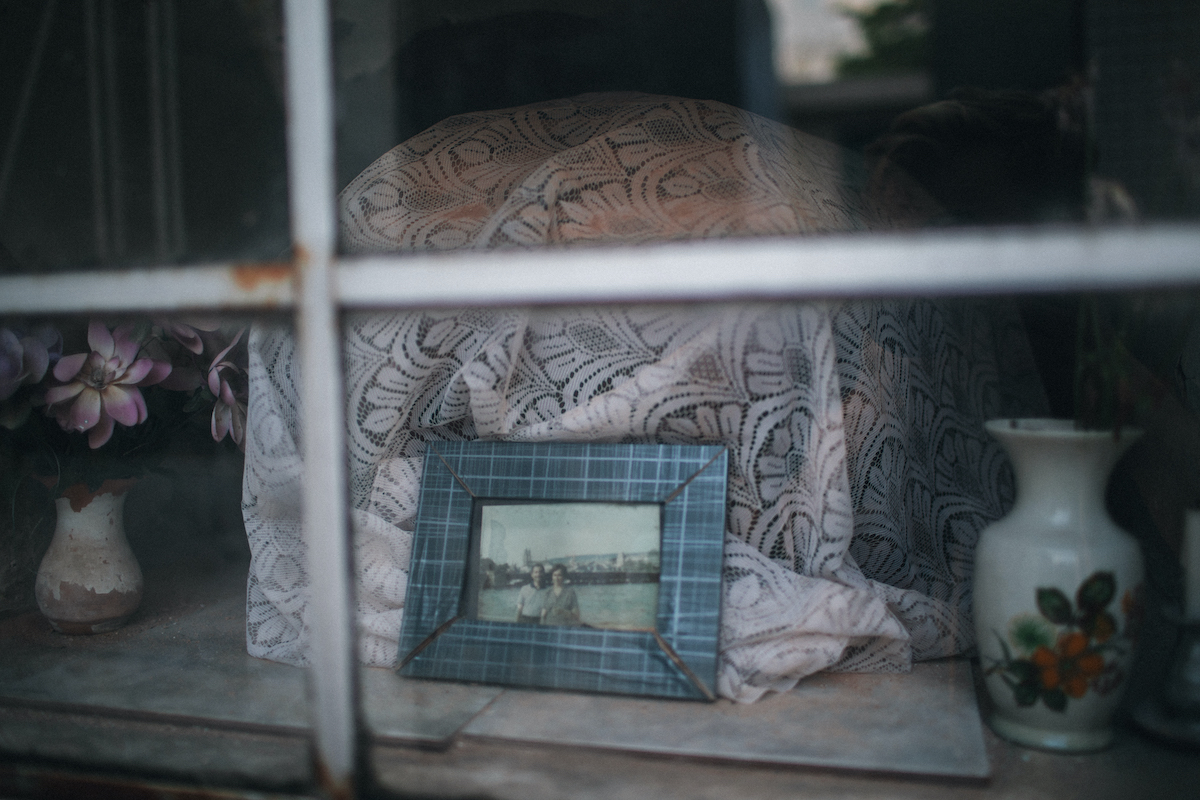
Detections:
473,503,661,630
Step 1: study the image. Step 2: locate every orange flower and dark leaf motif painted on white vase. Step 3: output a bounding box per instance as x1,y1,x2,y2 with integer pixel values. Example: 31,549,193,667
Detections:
985,572,1141,712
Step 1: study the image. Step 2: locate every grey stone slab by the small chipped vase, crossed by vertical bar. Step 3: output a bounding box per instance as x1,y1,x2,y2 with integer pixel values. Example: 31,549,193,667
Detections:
0,570,503,746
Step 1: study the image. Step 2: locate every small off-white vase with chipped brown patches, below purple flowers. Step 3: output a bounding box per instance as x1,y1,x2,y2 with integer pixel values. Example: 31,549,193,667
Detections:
34,481,142,633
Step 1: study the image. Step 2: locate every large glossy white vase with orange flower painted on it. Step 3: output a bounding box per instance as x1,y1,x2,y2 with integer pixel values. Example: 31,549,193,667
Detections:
974,420,1144,752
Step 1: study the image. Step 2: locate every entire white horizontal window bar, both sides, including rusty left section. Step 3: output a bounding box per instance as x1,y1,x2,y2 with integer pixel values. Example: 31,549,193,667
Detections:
0,224,1200,314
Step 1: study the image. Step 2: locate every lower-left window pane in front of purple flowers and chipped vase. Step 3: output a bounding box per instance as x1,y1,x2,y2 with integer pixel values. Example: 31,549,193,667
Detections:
0,317,311,788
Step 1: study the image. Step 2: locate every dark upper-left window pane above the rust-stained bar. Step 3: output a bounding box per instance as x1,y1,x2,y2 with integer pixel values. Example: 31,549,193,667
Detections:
0,0,288,272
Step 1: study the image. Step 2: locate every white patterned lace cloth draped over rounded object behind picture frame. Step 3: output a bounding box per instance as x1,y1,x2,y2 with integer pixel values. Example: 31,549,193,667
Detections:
244,95,1045,700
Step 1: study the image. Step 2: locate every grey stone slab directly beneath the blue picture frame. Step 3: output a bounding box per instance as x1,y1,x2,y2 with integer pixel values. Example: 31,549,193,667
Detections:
463,660,990,778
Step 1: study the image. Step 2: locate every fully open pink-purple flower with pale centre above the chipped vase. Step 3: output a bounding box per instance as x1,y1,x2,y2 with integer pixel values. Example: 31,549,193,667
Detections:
46,320,170,450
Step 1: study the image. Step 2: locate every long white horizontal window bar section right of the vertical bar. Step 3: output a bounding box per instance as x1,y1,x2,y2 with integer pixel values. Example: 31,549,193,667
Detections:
337,225,1200,308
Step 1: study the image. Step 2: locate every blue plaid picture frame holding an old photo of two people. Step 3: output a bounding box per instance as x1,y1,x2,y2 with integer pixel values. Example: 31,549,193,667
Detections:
400,441,728,700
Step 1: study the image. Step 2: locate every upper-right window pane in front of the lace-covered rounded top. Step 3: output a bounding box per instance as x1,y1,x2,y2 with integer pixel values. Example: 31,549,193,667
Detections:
334,0,1200,263
